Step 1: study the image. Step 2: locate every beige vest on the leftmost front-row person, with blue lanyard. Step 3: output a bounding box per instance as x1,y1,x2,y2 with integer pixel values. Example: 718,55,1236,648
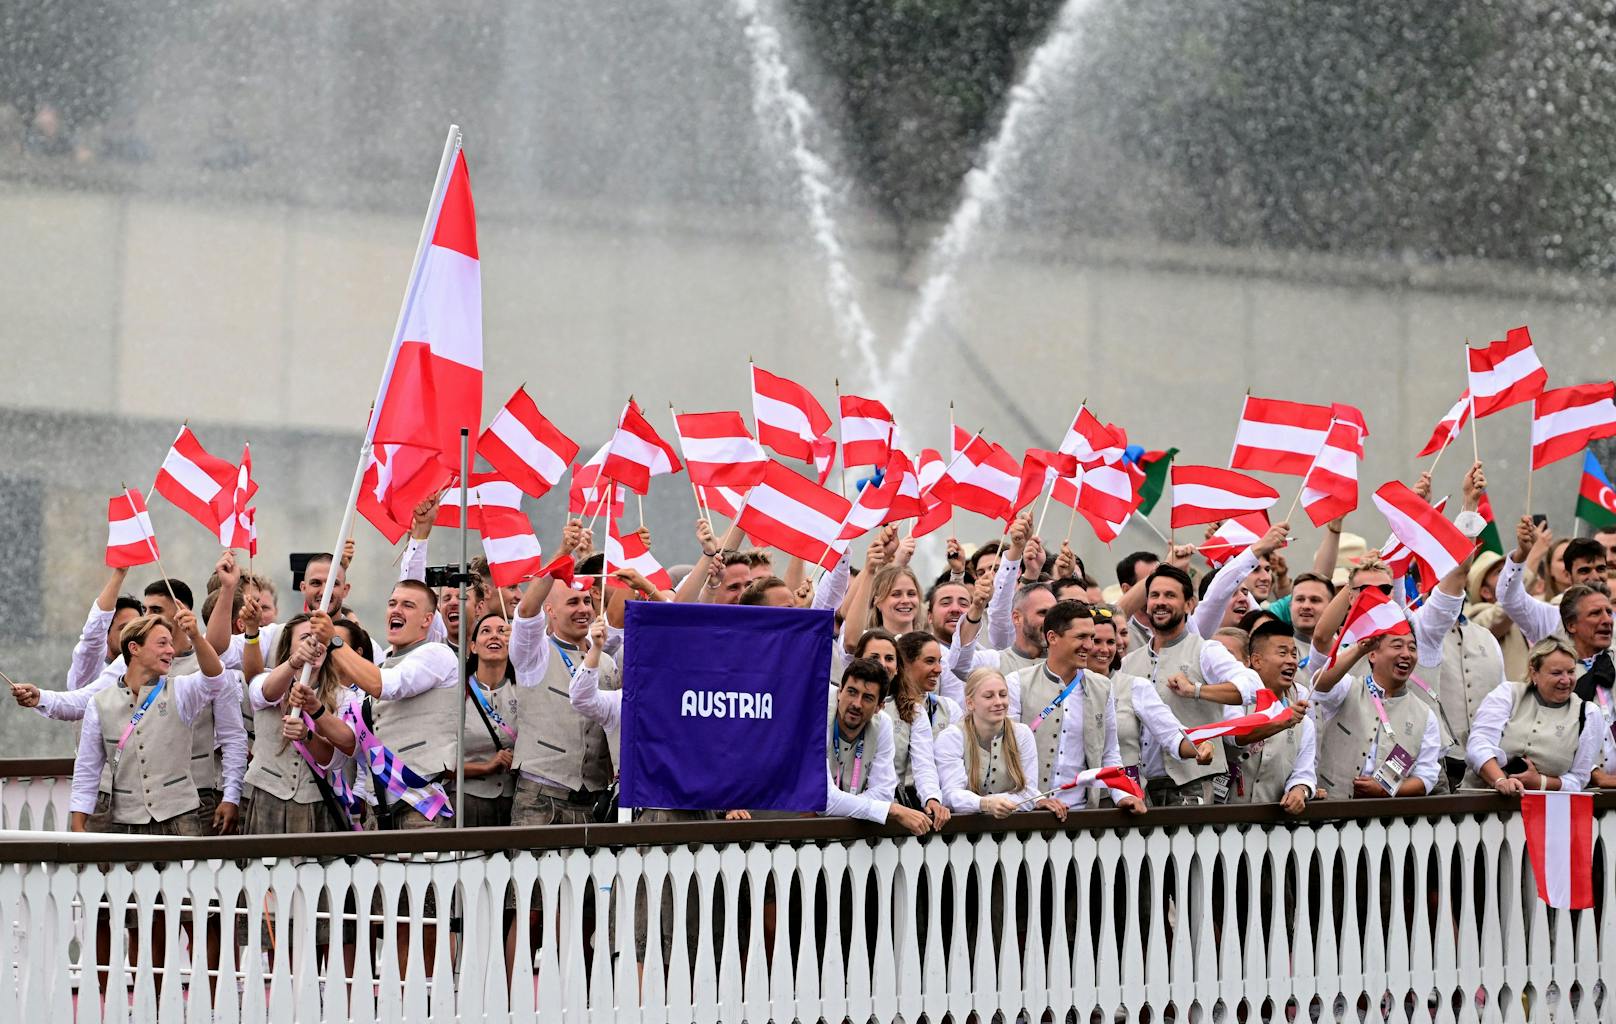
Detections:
92,680,202,825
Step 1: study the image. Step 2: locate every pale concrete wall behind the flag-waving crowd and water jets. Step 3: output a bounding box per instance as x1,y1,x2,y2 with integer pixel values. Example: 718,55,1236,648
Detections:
0,186,1613,753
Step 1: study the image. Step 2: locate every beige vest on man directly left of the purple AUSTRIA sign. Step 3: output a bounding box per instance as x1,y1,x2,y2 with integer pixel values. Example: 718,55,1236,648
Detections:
512,636,617,793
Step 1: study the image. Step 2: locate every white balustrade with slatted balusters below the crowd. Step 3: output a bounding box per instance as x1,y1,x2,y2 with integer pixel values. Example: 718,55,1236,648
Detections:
0,796,1616,1024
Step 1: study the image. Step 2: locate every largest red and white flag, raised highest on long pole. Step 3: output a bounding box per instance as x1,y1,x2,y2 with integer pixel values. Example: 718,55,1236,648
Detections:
370,143,483,474
